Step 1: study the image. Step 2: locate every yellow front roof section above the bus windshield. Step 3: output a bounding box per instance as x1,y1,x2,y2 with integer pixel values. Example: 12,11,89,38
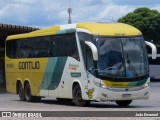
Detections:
77,22,142,36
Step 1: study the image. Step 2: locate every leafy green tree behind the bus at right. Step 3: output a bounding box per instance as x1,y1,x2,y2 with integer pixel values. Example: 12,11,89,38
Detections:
118,7,160,44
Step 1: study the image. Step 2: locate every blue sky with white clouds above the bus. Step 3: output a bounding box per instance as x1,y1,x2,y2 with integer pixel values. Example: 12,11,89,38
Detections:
0,0,160,28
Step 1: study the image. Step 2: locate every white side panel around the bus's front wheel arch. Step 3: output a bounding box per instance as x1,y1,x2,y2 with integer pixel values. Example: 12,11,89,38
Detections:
58,57,88,99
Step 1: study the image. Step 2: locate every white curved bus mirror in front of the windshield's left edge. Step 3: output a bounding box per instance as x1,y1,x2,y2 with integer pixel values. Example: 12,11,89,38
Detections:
85,41,98,61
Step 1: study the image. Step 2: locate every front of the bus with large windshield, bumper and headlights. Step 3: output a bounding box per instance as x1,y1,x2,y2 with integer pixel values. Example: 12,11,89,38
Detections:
79,29,156,106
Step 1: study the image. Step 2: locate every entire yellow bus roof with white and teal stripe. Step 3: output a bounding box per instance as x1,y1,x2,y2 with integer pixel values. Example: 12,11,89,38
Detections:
7,22,142,40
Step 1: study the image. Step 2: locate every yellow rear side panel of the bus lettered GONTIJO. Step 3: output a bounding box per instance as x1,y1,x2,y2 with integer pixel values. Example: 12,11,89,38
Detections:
6,58,48,96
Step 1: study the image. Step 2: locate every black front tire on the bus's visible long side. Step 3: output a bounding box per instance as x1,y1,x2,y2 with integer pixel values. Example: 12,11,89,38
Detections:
73,85,90,106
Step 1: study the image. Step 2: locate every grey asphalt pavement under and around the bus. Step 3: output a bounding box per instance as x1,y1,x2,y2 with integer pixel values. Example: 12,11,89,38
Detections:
0,82,160,120
